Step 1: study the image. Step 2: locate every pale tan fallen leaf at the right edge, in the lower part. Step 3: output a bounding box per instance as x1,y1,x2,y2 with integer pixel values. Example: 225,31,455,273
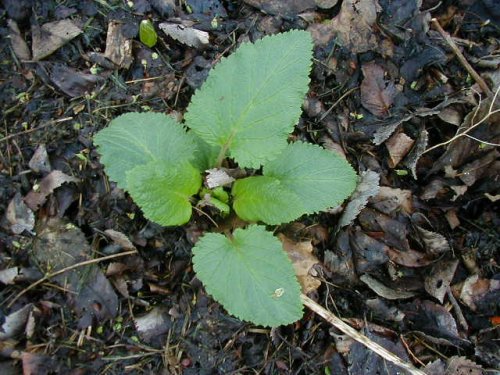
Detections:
460,275,500,313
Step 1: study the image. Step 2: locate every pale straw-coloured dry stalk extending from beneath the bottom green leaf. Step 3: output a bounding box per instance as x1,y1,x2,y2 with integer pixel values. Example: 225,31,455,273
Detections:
300,294,426,375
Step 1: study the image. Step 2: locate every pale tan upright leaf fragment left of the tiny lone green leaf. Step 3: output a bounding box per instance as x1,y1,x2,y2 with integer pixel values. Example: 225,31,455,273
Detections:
104,21,133,69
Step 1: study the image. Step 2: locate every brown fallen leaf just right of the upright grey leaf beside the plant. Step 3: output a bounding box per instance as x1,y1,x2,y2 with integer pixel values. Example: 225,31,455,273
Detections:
370,186,413,215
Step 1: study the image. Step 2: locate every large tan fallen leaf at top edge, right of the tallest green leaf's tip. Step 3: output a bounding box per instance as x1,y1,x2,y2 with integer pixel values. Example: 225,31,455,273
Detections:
331,0,382,53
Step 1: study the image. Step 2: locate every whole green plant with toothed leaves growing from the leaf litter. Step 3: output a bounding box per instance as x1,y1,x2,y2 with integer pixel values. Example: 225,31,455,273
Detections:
95,31,356,326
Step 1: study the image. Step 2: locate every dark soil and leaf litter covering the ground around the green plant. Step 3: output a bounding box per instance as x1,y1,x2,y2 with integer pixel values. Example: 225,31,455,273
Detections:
0,0,500,374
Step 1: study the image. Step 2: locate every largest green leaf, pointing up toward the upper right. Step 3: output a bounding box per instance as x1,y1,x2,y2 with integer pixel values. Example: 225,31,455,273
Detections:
185,30,312,168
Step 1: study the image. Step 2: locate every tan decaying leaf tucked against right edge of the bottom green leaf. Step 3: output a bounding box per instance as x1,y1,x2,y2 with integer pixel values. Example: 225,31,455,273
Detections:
278,233,321,294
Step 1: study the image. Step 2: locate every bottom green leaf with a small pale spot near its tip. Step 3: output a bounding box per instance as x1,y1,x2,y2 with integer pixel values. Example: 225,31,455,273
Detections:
193,225,302,327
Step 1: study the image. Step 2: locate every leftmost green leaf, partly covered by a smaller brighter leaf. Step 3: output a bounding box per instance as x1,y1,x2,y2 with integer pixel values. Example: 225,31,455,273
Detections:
94,112,197,189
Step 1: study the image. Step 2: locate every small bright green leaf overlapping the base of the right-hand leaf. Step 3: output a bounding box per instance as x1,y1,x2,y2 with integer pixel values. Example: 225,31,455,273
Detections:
232,176,305,225
